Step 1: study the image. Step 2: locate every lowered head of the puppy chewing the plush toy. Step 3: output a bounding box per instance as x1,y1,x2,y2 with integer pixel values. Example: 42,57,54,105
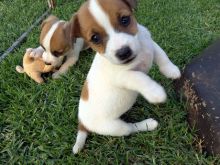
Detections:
40,15,72,66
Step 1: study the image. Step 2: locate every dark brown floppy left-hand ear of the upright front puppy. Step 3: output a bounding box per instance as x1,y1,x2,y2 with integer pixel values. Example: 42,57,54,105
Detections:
65,13,80,41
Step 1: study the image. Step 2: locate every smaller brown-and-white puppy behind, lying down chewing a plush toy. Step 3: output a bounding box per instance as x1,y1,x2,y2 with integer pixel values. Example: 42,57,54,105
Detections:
30,15,84,78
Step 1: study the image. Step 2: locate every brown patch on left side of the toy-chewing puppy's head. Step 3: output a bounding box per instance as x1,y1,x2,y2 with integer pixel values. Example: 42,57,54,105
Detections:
40,15,59,44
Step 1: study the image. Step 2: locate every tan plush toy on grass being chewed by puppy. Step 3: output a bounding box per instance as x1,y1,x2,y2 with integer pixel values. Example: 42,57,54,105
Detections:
16,48,55,83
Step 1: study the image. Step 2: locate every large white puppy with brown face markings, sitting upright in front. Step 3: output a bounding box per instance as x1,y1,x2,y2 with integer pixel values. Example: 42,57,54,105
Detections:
73,0,180,153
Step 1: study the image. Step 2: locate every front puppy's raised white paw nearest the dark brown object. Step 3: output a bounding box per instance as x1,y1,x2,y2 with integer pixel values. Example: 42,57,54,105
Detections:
160,64,181,79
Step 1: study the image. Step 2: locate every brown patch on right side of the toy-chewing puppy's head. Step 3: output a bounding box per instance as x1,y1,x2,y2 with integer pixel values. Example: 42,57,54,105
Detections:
50,22,72,57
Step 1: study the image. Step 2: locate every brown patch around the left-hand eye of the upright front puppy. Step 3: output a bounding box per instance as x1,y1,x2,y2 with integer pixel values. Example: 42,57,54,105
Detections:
74,1,108,54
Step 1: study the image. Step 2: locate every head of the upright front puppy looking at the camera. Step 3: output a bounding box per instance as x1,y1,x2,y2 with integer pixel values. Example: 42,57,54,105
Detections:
74,0,139,64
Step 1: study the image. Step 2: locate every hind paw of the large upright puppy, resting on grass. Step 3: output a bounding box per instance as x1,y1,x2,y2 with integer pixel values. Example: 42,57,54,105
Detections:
135,118,158,131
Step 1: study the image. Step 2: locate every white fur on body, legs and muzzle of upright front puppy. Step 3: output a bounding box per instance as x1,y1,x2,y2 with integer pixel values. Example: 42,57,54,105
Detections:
73,0,180,153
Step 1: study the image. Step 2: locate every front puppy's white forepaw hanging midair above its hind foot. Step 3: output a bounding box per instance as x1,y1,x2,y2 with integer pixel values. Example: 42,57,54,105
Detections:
144,84,167,104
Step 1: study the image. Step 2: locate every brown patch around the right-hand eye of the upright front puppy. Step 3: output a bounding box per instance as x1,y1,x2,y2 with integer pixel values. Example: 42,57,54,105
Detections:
98,0,138,35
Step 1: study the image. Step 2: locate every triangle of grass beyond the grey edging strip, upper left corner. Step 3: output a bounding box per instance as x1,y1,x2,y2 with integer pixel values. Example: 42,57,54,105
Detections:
0,0,47,55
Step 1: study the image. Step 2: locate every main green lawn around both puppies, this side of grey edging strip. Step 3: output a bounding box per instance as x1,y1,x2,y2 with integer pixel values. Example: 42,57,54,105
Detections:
0,0,220,164
